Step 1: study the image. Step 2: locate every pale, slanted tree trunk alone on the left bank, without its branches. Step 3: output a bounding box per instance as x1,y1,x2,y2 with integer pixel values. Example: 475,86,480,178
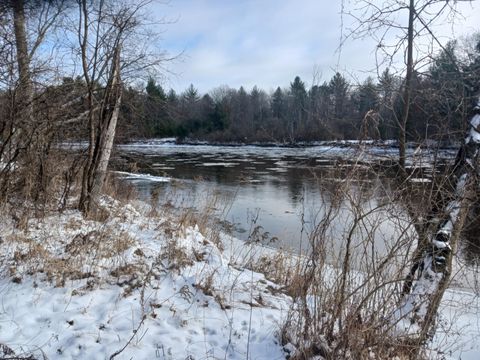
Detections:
79,45,122,216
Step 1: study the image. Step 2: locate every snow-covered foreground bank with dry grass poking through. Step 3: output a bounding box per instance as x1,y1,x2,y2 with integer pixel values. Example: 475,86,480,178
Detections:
0,199,480,360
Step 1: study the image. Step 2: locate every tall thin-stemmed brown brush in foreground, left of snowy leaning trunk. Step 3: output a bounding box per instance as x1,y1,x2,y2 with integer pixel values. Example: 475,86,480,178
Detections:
270,158,446,360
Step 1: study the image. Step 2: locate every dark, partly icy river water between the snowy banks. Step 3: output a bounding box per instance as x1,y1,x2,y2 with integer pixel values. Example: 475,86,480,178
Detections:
114,141,462,255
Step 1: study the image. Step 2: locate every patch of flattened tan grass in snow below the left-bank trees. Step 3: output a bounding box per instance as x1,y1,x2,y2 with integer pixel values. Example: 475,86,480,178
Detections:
2,194,141,286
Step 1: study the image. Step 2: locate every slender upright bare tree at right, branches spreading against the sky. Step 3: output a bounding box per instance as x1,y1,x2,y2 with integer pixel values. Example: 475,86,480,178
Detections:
347,0,468,173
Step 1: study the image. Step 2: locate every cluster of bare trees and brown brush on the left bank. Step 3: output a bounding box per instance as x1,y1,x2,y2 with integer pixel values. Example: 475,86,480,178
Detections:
0,0,168,225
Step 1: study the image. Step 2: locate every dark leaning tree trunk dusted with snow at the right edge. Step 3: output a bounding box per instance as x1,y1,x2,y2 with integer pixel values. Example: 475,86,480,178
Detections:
394,100,480,343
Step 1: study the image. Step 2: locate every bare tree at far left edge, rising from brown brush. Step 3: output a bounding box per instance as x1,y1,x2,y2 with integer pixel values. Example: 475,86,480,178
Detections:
0,0,66,210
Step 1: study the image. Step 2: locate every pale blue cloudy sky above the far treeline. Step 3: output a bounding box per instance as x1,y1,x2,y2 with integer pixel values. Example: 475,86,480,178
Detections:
149,0,480,93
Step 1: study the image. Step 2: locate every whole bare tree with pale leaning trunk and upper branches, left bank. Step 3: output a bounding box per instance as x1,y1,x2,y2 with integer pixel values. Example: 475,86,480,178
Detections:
76,0,163,215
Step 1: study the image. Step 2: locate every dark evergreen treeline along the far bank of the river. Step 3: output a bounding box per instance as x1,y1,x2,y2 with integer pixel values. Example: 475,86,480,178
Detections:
118,39,480,143
